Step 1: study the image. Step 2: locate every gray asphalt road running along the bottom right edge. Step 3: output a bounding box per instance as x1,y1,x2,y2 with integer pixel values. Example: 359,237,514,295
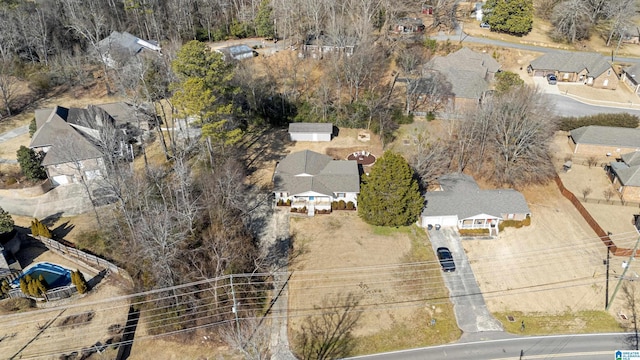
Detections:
350,334,632,360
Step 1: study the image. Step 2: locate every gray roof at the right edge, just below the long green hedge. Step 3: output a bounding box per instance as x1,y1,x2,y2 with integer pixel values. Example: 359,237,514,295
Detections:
571,125,640,148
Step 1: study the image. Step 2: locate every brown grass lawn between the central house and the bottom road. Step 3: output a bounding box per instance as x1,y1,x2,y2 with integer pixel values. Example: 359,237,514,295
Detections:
289,212,460,355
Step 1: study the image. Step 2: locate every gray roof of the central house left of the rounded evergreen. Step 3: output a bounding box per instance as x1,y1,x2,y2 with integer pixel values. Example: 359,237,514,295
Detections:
274,150,360,196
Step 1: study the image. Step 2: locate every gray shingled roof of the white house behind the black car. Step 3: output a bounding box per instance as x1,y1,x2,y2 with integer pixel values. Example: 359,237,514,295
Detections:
422,189,531,219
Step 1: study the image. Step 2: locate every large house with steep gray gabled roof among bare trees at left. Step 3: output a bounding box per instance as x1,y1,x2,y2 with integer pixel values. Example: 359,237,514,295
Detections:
29,105,139,185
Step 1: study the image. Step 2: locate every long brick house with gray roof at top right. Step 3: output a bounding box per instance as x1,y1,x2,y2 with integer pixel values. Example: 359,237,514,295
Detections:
527,51,618,90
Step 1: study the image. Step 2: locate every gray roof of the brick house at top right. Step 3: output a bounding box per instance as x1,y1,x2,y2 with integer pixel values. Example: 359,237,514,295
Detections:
531,51,611,77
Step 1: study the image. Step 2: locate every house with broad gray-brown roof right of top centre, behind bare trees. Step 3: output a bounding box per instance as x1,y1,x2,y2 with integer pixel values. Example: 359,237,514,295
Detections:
424,47,501,109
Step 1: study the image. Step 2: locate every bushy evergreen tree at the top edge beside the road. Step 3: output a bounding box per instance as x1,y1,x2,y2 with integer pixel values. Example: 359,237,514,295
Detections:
483,0,533,36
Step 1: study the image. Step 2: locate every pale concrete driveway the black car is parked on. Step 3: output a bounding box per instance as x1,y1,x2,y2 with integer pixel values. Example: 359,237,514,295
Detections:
428,228,504,333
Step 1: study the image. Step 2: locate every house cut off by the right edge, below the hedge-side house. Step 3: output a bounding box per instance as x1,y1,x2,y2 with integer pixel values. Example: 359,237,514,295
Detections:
607,151,640,202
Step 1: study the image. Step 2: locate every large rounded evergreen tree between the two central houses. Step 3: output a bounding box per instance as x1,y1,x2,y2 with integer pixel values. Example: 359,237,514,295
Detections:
358,151,424,226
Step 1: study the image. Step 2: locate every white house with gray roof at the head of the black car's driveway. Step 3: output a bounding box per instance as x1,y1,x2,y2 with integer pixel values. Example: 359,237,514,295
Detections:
420,174,531,235
